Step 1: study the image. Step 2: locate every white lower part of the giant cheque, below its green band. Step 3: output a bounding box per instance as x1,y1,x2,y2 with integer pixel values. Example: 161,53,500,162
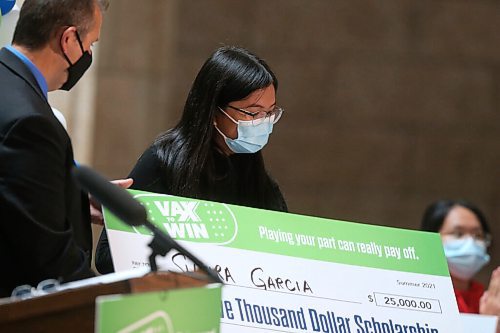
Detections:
110,231,461,333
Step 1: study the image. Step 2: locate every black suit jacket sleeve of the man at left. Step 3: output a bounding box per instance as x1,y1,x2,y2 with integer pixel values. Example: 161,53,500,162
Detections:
0,115,93,294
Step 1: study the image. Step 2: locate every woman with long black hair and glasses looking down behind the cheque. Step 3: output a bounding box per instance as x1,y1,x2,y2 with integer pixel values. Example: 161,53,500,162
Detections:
96,46,287,273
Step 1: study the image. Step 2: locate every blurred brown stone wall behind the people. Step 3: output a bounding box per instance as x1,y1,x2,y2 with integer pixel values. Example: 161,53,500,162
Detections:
52,0,500,282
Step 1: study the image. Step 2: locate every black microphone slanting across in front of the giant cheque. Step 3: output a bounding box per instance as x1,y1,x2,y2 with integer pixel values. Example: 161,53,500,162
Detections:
71,165,223,283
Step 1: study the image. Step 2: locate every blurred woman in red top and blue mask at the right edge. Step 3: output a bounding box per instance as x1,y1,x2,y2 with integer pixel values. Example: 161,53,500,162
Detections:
421,200,500,316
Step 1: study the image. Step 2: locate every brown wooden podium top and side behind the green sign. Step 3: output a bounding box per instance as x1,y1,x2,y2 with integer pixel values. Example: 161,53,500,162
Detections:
0,272,210,333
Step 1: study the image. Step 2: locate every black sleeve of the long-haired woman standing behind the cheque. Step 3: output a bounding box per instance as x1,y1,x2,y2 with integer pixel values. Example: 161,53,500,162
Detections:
95,147,168,274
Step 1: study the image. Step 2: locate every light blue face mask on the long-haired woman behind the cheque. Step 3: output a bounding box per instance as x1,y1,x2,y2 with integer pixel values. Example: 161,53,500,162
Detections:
214,108,275,154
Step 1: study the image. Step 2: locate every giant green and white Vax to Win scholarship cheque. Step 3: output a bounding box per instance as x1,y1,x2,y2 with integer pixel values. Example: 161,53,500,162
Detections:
105,190,461,333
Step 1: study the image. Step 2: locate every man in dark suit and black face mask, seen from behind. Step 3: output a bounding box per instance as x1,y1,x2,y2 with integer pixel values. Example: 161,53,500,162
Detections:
0,0,116,297
